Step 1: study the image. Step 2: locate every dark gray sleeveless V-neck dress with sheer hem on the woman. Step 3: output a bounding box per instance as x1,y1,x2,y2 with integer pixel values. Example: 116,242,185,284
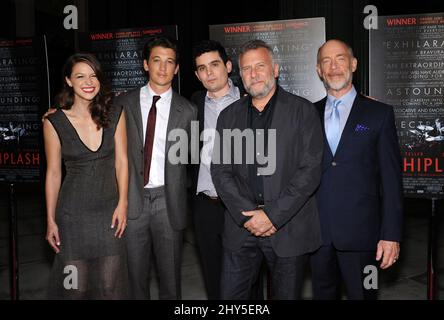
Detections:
48,106,128,299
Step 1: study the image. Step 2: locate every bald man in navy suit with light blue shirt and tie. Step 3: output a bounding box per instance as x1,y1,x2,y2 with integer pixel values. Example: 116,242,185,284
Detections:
311,40,402,299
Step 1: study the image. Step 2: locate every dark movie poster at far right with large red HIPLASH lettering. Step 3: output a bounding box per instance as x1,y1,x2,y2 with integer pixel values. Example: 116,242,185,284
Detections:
370,13,444,198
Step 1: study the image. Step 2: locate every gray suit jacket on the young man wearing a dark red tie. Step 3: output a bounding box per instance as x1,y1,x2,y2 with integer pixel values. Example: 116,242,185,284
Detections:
114,88,197,230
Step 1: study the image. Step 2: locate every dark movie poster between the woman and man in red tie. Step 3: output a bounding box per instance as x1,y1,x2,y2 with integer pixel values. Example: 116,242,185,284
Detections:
79,26,180,95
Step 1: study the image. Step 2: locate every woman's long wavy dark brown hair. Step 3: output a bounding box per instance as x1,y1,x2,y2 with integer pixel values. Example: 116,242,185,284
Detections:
55,53,112,129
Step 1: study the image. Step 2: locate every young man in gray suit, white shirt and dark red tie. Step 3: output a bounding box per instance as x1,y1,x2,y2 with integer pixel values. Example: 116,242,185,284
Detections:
116,37,197,299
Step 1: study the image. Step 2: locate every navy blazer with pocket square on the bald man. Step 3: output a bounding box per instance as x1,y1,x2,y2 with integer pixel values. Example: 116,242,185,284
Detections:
316,94,403,251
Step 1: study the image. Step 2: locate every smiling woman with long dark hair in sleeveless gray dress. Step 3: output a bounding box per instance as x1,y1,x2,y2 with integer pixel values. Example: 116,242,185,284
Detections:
43,54,128,299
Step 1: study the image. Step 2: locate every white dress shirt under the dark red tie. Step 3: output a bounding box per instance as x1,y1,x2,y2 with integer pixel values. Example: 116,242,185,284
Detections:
140,83,173,188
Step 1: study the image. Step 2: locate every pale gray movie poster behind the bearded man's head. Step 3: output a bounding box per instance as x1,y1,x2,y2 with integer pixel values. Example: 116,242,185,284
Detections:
210,18,326,102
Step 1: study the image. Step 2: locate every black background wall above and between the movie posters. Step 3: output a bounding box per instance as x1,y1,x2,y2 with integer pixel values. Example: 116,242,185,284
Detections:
0,0,444,97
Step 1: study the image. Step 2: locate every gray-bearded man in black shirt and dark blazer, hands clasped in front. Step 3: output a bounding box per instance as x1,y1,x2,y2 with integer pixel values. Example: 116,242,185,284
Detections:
211,40,323,299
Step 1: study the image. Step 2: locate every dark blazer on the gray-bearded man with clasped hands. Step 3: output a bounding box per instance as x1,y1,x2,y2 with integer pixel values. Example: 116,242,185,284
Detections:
211,87,323,257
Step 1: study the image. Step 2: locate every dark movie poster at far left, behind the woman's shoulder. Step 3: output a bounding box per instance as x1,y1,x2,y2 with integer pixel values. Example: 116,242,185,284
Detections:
0,37,49,183
